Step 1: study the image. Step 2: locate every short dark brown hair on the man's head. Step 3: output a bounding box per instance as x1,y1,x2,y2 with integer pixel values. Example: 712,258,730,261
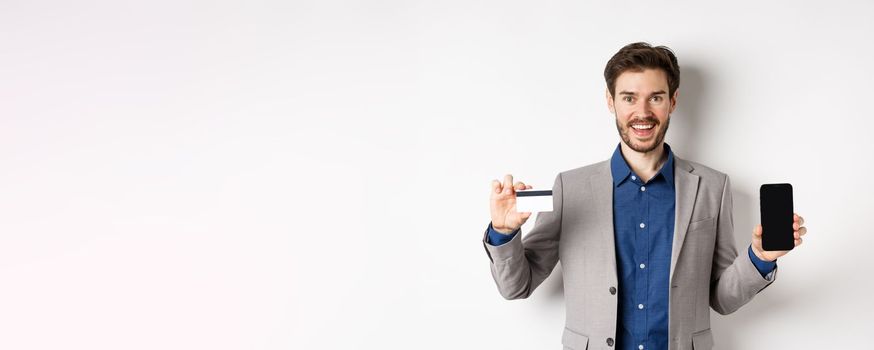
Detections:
604,42,680,98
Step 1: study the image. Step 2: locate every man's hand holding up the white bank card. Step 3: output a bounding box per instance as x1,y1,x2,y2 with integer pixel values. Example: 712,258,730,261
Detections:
489,174,533,234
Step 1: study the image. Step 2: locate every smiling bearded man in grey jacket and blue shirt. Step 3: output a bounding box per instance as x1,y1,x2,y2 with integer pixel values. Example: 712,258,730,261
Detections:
484,43,807,350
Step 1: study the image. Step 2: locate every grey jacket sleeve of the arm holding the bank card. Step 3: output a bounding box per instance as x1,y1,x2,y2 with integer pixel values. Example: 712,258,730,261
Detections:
483,174,562,300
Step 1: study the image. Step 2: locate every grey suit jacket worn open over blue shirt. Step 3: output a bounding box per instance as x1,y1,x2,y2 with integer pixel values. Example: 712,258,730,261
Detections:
483,156,776,350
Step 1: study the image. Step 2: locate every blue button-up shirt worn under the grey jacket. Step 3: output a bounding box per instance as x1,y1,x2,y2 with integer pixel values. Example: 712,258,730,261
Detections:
488,144,776,350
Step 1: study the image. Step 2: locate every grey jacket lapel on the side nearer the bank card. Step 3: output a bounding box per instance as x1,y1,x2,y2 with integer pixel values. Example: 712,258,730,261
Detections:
589,161,619,285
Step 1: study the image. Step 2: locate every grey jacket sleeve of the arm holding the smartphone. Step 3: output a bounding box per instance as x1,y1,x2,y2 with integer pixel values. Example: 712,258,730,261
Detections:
710,176,777,315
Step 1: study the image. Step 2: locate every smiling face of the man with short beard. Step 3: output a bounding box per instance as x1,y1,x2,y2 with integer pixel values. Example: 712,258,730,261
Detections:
607,69,678,153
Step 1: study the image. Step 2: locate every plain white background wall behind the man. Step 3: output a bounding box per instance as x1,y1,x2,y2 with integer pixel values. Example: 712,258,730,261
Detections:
0,0,874,349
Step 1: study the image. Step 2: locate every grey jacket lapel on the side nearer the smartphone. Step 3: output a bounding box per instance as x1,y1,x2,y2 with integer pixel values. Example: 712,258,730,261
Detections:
670,159,698,283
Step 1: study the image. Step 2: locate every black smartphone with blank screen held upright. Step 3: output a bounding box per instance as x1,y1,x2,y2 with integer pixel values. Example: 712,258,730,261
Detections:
759,184,795,251
